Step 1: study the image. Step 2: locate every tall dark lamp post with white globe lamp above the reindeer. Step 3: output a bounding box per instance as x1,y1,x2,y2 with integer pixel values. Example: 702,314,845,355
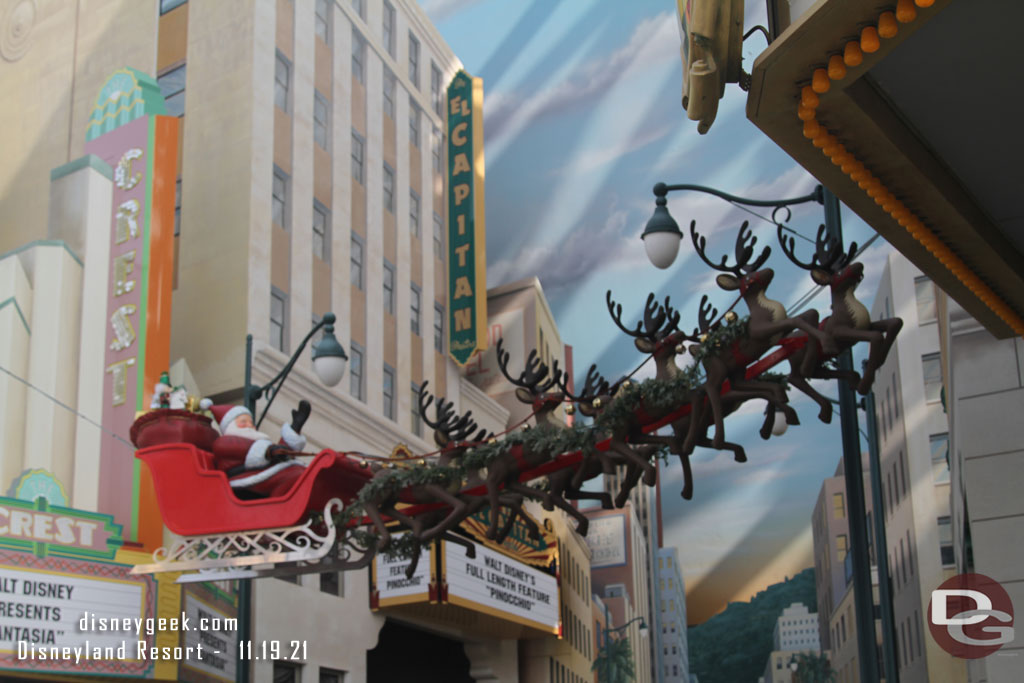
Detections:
641,182,884,683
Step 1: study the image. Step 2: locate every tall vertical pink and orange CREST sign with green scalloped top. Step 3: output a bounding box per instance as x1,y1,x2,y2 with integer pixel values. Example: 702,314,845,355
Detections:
85,69,178,549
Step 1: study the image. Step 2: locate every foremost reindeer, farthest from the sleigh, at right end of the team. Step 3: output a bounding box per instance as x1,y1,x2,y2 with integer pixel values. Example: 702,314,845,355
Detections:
778,224,903,411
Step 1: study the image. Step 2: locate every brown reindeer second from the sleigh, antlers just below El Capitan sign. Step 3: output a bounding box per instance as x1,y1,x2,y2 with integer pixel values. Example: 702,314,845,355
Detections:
485,340,590,539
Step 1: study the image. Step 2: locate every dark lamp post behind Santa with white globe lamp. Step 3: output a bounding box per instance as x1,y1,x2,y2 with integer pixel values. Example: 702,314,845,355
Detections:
234,313,348,683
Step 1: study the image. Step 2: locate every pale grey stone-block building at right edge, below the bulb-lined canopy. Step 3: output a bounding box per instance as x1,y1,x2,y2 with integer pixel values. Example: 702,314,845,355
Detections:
939,294,1024,683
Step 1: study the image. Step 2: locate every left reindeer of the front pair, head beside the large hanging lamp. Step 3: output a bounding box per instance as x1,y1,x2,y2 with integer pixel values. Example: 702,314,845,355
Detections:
686,221,838,450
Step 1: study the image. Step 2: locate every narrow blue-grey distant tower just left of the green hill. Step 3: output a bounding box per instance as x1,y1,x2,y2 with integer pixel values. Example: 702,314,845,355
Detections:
654,547,690,683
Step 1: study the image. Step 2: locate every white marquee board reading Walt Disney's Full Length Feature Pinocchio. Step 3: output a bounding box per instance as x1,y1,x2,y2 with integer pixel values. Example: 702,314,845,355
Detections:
441,542,559,633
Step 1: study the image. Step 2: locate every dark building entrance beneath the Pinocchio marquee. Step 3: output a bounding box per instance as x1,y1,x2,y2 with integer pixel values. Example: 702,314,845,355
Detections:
367,620,473,683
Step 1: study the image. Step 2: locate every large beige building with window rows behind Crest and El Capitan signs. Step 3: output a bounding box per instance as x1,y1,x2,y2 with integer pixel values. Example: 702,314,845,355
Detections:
0,0,528,682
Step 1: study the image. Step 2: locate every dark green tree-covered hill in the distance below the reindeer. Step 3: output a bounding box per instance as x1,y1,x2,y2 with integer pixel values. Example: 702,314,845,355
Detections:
687,568,817,683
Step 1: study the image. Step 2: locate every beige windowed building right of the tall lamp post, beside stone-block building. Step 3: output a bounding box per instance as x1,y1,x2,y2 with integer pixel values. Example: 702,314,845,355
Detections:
871,254,964,683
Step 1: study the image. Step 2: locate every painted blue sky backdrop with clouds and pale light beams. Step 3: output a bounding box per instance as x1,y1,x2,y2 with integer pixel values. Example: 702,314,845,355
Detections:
420,0,890,624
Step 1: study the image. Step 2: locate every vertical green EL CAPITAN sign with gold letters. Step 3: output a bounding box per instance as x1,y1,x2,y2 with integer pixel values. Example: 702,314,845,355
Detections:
447,71,487,366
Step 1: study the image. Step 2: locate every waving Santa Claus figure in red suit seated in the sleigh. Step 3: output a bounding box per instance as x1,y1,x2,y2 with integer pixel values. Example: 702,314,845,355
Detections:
210,400,310,497
